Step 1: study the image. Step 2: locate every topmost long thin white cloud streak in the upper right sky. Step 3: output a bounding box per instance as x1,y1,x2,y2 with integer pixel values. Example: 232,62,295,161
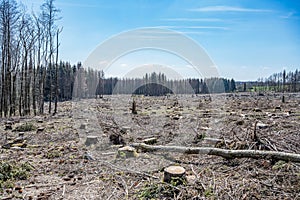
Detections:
189,6,272,12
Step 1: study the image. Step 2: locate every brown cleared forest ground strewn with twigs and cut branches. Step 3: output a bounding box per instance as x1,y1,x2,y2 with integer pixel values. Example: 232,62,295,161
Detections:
0,93,300,200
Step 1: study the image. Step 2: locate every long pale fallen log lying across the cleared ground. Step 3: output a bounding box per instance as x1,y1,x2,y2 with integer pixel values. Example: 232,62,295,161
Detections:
130,143,300,162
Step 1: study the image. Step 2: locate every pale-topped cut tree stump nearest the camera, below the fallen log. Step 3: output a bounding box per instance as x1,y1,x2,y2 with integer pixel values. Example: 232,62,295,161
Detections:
163,166,185,184
